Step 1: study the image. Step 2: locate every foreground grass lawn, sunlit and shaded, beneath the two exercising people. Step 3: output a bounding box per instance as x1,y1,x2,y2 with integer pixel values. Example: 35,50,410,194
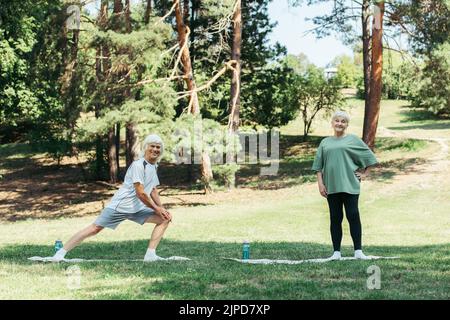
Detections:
0,188,450,299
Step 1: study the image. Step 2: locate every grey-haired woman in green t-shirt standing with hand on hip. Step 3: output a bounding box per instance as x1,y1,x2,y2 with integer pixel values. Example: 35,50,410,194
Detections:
312,111,378,260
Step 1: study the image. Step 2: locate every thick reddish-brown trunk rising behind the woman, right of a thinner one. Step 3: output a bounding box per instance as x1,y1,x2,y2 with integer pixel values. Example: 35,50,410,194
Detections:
363,1,384,150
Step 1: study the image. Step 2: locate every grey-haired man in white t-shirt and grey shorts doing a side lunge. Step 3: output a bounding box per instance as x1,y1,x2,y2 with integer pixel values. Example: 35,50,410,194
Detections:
53,134,172,261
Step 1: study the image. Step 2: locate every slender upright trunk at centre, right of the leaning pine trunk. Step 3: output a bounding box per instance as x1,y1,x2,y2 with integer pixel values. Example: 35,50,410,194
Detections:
228,0,242,133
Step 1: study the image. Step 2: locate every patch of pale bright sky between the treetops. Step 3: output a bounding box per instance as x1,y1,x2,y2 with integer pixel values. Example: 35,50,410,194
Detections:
268,0,353,67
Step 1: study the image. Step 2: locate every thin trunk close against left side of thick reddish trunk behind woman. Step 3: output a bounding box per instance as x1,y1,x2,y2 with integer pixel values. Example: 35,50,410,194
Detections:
361,0,371,141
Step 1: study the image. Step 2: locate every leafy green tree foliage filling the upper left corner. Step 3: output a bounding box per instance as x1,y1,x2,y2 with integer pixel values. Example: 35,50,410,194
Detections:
0,0,59,129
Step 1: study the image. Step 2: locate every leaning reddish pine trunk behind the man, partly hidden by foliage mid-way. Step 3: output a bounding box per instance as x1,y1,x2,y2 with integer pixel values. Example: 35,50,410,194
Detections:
174,0,213,193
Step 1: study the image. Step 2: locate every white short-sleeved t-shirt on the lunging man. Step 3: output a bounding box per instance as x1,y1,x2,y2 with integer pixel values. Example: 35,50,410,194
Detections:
106,158,159,213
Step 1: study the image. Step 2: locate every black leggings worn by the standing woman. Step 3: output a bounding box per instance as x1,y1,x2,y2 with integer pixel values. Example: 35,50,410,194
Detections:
327,192,361,251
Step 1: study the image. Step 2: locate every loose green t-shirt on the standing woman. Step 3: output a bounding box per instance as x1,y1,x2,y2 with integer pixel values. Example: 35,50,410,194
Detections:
312,134,378,194
